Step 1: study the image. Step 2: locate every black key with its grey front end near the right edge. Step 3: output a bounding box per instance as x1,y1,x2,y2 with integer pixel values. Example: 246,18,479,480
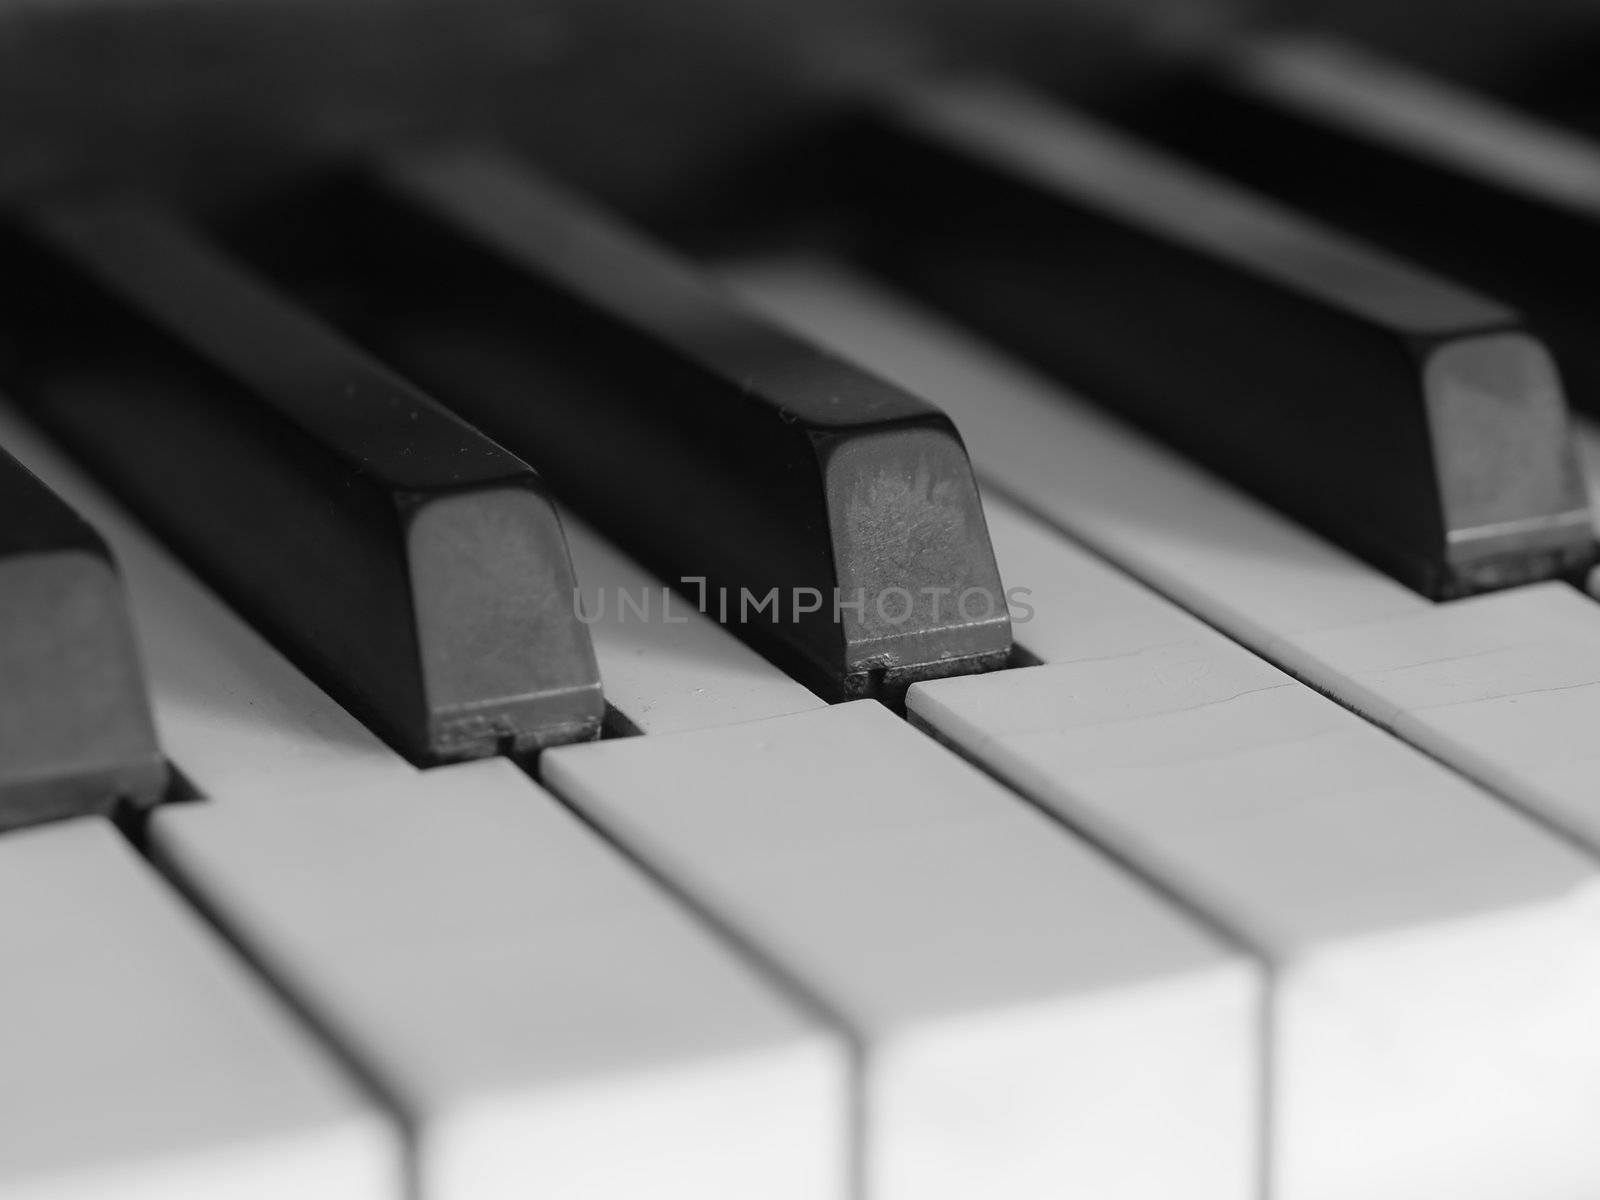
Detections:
858,83,1594,598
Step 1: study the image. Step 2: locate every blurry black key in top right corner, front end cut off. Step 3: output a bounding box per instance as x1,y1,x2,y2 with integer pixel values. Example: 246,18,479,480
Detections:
1122,37,1600,422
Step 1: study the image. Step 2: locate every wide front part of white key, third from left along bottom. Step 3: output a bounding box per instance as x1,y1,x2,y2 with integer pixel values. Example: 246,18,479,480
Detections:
539,704,1262,1200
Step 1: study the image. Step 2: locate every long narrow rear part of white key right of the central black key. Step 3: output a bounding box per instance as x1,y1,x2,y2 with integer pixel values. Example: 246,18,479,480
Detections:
723,258,1429,659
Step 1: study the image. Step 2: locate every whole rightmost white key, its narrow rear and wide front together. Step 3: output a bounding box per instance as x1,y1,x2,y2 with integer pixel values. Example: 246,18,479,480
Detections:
730,266,1600,848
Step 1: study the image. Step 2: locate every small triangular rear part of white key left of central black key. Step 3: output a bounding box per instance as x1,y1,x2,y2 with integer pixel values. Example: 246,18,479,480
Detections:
562,512,822,733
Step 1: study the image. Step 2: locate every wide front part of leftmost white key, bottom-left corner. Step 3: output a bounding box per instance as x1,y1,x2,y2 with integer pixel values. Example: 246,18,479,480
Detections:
0,819,405,1200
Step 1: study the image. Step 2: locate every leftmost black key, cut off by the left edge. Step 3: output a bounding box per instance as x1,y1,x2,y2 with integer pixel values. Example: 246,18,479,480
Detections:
0,442,166,830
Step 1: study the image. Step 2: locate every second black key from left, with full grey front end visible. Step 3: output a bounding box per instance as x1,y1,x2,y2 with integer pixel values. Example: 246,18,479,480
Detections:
5,202,603,763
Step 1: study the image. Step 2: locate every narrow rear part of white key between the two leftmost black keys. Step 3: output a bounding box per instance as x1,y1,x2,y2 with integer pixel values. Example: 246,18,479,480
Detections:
0,405,414,803
